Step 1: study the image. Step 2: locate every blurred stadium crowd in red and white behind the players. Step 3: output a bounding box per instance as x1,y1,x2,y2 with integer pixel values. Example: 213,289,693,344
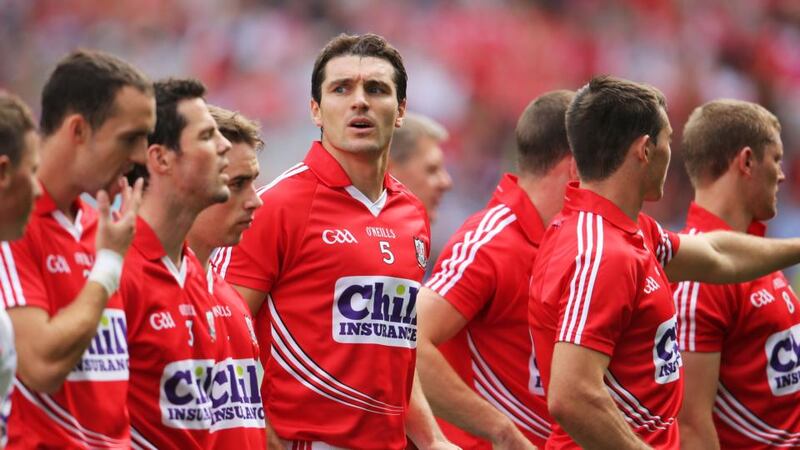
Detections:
0,0,800,276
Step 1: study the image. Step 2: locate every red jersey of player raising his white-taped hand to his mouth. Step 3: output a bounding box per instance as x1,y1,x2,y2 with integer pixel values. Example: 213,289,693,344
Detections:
0,191,130,449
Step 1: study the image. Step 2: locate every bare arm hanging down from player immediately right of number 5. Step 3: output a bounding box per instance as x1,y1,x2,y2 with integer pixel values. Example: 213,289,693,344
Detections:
417,288,535,449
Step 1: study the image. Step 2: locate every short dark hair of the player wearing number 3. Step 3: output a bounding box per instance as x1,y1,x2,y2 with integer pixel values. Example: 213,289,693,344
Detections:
147,78,206,152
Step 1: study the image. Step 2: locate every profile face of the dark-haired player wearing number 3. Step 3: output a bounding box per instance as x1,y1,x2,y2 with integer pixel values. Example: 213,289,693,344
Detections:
174,98,231,207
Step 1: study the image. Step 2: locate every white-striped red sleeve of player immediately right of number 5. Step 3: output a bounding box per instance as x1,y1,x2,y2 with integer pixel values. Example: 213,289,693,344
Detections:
425,223,497,321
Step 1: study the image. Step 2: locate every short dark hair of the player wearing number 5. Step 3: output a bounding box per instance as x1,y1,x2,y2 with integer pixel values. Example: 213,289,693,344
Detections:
311,33,408,103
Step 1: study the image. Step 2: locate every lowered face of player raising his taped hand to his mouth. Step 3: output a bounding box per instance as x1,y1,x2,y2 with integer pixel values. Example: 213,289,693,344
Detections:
82,86,156,195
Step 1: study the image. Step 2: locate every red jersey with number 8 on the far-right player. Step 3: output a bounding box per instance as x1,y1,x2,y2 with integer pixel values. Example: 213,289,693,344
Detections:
675,203,800,449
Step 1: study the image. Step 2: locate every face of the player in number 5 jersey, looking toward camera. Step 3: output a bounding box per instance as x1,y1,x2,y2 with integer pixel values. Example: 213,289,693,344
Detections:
311,55,405,153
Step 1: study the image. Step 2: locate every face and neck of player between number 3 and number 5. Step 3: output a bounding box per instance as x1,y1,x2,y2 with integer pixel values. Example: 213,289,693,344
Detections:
192,142,263,247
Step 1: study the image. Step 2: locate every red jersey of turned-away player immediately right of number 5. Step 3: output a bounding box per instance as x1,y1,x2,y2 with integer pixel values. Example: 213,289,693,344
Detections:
426,175,552,449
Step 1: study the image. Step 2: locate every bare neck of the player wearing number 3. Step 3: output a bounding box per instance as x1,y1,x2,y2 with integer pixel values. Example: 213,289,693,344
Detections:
139,194,200,266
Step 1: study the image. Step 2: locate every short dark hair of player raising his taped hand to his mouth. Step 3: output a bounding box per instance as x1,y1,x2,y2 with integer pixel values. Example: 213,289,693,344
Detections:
41,50,153,136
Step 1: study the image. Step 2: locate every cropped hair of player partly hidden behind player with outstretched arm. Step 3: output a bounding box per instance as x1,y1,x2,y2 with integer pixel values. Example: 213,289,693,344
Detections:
516,90,575,175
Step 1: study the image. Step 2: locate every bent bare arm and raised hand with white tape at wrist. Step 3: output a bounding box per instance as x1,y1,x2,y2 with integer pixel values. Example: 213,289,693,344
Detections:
8,180,142,393
